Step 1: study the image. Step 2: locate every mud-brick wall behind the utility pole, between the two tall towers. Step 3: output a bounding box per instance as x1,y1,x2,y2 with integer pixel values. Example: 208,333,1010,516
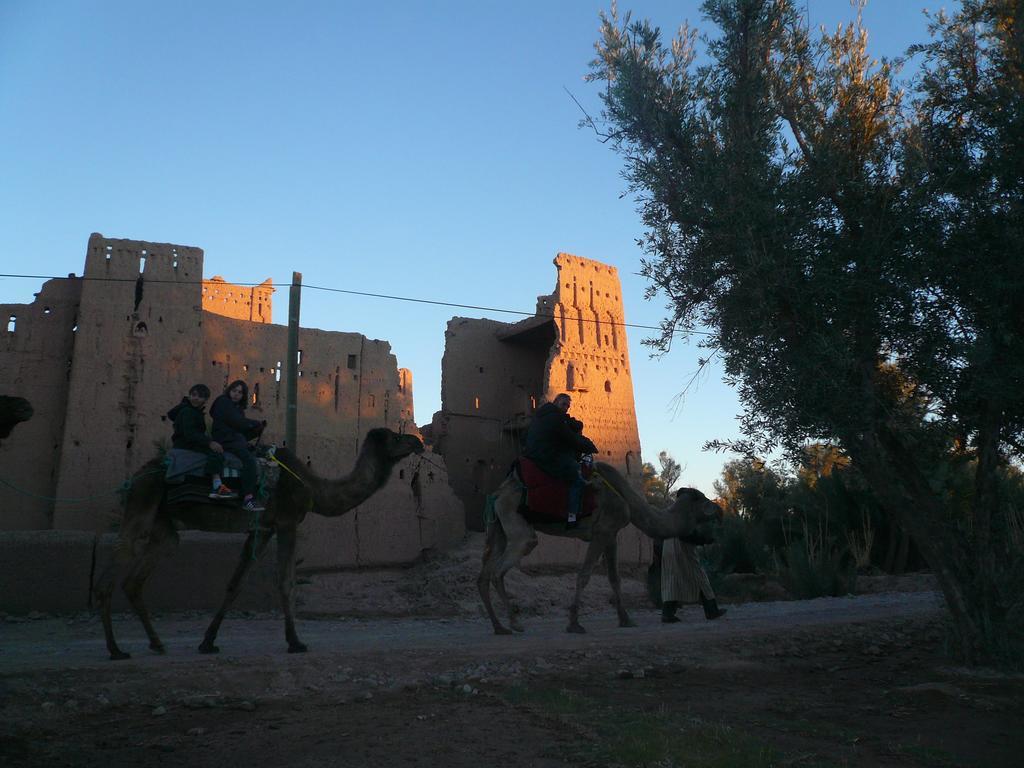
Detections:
203,314,456,568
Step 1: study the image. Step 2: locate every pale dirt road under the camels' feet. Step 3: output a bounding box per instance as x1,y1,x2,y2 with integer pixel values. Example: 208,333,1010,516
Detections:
0,592,941,674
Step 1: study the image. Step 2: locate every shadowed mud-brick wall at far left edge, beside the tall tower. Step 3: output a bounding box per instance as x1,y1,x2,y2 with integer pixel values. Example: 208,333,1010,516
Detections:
0,278,82,530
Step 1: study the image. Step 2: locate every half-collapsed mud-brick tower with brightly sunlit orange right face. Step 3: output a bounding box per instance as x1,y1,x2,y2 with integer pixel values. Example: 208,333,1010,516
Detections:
431,253,642,548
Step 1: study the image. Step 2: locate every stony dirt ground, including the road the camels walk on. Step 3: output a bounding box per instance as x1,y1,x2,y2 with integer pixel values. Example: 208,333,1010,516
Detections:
0,538,1024,768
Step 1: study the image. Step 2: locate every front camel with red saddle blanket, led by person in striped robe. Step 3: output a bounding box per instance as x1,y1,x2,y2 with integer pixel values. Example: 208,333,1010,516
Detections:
476,462,722,635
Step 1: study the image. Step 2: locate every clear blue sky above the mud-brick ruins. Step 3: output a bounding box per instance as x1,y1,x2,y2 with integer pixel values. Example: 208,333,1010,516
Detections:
0,0,950,494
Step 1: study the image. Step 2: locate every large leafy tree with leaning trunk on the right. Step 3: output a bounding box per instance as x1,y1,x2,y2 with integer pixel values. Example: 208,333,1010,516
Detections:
590,0,1024,662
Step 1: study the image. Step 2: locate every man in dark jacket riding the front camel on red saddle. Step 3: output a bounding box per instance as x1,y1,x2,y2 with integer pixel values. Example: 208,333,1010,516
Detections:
522,392,597,524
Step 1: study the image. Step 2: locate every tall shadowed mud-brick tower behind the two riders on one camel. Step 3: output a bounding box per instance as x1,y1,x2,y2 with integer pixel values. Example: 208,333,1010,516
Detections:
53,233,203,531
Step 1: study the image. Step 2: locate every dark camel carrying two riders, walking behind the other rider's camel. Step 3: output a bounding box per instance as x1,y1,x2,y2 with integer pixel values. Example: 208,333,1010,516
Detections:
95,427,423,660
